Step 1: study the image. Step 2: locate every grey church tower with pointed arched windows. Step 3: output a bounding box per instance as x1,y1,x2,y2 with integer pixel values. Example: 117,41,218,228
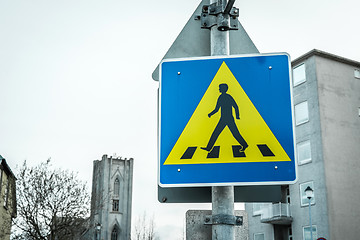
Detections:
89,155,133,240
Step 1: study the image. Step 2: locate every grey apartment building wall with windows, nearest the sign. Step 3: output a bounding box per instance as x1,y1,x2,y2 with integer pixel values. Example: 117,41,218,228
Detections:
289,56,329,239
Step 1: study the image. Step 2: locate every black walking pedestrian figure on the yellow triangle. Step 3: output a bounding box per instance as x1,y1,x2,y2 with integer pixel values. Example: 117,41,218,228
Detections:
201,83,248,152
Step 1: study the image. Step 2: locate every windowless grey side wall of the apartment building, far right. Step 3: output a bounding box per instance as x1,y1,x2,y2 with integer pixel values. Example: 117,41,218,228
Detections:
316,57,360,239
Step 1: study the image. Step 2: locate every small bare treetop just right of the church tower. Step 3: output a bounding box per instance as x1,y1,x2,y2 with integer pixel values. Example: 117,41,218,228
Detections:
132,212,156,240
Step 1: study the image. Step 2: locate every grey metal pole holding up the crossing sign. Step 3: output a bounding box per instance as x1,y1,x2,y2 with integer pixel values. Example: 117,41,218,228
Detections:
210,0,235,240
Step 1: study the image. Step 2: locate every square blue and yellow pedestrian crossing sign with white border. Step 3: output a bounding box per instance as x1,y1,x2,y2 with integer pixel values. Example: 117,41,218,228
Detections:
158,54,296,187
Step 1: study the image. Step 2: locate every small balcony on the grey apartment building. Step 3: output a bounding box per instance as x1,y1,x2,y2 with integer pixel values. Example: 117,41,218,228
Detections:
261,203,292,225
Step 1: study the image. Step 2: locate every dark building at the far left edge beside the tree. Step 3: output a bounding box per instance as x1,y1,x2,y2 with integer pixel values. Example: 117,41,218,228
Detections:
0,155,16,240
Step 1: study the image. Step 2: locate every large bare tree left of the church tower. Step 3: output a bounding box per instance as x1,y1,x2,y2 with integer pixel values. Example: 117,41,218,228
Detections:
13,160,90,240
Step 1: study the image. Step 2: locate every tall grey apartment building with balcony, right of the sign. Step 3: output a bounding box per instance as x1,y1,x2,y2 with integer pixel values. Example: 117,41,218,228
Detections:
245,50,360,240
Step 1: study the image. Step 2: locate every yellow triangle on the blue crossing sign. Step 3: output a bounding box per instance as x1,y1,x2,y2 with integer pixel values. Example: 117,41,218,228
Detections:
164,62,291,165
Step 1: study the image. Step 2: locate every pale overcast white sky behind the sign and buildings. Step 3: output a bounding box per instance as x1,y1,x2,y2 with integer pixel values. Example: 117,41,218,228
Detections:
0,0,360,240
